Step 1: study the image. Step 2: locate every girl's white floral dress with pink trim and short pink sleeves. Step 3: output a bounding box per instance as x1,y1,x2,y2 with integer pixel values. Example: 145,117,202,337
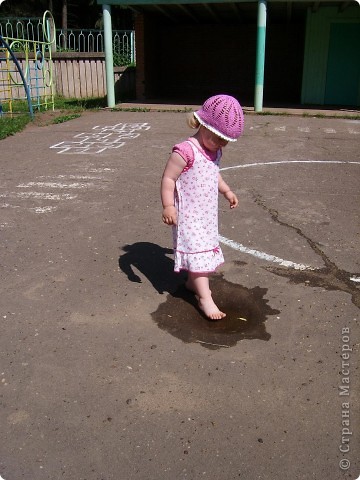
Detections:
173,140,224,273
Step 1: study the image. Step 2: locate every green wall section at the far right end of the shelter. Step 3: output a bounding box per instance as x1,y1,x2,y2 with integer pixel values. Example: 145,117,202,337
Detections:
302,5,360,106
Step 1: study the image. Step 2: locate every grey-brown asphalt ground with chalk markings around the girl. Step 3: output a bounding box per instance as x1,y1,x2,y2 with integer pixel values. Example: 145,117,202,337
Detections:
0,111,360,480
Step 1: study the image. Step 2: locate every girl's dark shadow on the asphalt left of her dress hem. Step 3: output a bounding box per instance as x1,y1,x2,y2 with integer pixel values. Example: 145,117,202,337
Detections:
119,242,186,294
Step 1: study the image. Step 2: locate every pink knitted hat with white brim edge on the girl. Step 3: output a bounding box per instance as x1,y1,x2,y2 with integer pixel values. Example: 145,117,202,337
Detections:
194,95,244,142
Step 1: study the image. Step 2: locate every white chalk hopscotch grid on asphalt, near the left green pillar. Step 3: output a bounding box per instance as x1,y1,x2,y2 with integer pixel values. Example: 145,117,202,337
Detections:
50,123,150,155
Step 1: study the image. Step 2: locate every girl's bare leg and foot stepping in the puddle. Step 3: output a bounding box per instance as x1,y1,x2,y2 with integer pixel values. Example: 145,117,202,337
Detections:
186,272,226,320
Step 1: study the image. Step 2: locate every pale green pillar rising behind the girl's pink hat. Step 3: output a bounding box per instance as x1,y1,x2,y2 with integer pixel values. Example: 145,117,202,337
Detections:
254,0,266,112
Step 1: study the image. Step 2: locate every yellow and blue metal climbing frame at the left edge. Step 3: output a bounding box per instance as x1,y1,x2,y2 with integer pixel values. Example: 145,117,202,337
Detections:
0,10,55,117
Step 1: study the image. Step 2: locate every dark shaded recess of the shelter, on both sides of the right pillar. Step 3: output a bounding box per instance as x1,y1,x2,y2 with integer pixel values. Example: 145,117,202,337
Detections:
135,4,306,104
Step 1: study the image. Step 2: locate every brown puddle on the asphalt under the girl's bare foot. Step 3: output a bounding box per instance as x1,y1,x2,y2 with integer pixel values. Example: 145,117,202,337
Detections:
152,275,279,349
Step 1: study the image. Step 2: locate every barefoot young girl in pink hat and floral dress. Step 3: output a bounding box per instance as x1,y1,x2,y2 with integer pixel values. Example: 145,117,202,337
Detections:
161,95,244,320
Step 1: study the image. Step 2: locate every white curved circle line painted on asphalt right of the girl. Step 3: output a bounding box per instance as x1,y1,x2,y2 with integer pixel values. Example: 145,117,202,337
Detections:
219,160,360,283
